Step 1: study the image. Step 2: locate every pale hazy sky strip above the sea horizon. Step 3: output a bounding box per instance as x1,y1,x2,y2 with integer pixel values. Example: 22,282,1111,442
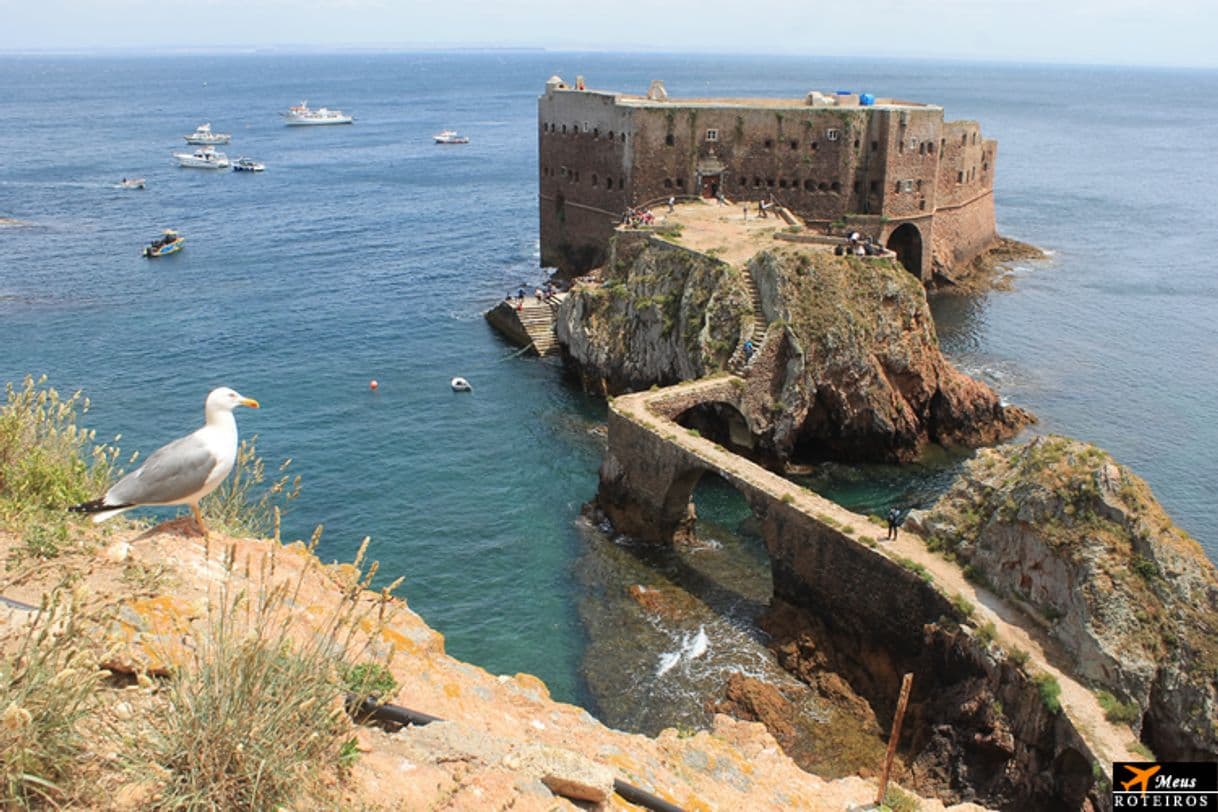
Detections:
0,0,1218,67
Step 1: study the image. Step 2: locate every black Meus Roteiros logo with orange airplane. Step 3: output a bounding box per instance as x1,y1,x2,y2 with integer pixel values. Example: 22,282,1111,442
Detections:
1112,761,1218,810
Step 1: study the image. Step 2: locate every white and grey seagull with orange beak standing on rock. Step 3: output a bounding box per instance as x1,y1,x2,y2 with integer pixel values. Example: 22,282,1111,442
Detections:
68,386,258,538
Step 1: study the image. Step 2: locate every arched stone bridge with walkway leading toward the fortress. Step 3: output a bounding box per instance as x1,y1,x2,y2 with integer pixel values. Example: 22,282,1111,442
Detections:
597,375,1141,810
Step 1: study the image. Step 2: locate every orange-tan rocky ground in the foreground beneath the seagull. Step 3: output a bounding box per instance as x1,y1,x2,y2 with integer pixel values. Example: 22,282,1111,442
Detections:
0,519,984,812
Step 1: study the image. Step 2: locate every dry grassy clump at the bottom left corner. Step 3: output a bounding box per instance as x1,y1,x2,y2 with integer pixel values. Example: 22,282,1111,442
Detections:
0,590,102,808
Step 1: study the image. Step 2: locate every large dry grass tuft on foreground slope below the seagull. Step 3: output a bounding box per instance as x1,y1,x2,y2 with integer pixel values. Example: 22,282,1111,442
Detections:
127,533,401,810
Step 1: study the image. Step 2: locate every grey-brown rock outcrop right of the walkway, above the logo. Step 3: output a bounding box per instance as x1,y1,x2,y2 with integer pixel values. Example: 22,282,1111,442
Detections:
915,436,1218,761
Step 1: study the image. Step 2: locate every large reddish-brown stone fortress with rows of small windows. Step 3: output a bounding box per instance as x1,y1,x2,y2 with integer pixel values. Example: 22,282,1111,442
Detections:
537,77,998,282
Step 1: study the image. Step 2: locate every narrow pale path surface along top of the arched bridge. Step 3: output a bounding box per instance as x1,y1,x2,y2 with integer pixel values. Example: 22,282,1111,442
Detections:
610,377,1145,767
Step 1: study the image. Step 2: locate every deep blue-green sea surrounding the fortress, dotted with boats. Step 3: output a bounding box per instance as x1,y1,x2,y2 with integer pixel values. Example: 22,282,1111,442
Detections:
0,52,1218,728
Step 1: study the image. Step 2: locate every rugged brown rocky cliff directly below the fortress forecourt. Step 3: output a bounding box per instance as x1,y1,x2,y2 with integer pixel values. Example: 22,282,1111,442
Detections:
558,235,1032,461
